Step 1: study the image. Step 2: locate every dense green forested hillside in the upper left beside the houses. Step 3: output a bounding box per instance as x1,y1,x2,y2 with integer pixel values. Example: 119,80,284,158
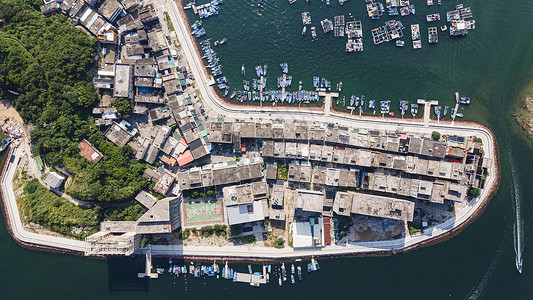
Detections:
0,0,148,202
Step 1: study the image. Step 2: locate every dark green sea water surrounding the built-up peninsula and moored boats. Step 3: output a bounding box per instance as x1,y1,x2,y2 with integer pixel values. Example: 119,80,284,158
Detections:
0,0,533,299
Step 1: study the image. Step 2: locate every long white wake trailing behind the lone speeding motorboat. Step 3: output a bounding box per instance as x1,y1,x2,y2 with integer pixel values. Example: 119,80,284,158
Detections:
507,151,524,273
